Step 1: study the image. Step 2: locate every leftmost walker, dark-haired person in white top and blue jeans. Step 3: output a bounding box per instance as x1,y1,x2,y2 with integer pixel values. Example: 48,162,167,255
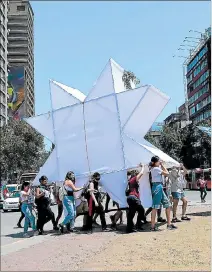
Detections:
20,182,37,238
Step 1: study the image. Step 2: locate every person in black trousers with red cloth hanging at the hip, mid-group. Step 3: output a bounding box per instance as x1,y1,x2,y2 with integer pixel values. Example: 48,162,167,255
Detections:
87,172,108,231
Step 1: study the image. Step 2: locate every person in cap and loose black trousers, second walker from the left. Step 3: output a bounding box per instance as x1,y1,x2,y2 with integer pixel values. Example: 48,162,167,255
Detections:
35,176,59,235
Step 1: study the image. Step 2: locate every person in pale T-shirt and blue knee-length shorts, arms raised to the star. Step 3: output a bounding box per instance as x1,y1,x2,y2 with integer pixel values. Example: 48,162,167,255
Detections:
150,156,177,231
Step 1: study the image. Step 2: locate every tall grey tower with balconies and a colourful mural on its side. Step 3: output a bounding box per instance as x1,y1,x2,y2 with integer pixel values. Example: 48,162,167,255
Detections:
8,0,35,119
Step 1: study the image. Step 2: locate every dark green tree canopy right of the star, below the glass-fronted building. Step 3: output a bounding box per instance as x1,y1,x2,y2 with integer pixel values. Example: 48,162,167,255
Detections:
146,124,211,169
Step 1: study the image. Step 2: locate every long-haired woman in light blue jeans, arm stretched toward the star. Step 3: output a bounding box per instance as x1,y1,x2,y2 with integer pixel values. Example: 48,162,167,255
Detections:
59,171,84,233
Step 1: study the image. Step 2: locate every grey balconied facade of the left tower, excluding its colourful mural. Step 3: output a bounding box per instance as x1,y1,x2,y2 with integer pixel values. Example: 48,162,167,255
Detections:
8,0,35,117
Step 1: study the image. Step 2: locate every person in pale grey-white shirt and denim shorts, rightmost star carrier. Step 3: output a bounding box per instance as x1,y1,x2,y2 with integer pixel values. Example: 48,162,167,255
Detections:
169,164,190,223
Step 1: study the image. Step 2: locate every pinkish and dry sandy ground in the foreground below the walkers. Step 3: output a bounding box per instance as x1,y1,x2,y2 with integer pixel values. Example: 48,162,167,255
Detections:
1,206,211,271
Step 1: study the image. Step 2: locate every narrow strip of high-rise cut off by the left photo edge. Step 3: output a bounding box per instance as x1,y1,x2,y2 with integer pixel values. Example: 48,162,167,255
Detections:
0,1,8,127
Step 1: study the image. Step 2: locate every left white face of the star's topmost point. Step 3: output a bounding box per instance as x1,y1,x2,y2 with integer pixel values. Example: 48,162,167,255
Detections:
85,60,115,101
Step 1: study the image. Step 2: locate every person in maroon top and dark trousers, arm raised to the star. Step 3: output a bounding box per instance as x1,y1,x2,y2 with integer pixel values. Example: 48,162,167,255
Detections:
126,164,146,233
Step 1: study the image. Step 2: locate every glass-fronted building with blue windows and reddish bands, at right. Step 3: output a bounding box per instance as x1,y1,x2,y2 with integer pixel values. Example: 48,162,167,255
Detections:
186,28,211,124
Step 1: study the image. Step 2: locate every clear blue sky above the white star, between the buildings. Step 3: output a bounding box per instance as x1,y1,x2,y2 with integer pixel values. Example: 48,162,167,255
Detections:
31,1,210,121
